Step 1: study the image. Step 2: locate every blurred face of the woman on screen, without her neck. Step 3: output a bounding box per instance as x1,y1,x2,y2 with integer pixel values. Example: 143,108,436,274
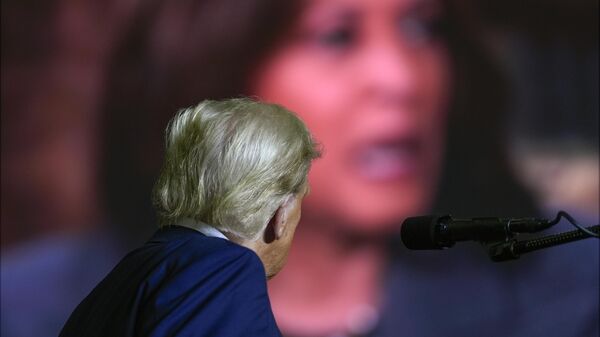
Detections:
253,0,450,233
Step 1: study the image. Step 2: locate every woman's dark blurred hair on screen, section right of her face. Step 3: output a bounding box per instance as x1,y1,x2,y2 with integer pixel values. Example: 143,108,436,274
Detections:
433,1,537,216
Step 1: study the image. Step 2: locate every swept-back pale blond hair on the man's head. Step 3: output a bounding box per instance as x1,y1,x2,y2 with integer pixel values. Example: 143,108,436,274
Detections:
154,98,319,240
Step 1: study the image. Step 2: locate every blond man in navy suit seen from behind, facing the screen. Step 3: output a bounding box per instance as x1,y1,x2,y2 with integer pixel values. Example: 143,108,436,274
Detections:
61,99,319,337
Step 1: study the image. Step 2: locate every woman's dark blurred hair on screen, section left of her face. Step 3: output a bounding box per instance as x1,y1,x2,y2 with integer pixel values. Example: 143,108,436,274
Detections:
99,0,298,239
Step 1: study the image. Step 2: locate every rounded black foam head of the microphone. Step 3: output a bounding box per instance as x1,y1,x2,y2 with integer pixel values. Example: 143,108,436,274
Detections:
400,216,448,250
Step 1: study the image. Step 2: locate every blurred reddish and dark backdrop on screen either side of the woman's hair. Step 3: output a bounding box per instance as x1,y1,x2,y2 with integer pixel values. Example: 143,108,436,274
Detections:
0,0,600,334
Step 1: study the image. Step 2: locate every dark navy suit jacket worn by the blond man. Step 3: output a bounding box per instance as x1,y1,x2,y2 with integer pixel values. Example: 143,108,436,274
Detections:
60,226,280,337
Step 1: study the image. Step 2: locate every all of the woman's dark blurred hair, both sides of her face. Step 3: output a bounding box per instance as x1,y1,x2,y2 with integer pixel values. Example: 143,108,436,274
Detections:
100,0,533,242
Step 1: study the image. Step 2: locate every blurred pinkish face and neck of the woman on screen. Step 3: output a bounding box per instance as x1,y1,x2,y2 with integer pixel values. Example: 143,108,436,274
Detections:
254,0,452,335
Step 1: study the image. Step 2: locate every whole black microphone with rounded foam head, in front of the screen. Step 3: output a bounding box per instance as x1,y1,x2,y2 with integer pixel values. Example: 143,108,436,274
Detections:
400,215,552,250
